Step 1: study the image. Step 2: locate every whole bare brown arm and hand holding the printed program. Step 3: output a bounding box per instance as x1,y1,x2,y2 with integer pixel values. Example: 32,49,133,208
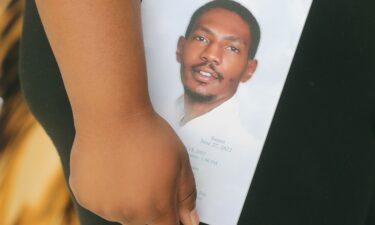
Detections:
36,0,198,225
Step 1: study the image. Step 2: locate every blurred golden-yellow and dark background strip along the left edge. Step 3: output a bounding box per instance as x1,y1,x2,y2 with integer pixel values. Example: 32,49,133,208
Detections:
0,0,79,225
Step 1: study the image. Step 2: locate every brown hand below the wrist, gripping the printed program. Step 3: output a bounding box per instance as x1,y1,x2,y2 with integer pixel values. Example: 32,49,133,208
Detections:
69,113,199,225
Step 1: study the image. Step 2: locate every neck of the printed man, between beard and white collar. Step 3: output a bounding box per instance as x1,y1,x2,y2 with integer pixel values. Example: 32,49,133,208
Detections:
181,95,230,125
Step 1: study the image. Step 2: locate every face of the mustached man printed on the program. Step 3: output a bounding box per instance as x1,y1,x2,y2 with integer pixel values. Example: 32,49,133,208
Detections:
176,8,257,102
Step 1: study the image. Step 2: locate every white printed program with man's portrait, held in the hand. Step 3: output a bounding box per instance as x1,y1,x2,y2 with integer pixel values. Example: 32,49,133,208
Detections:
142,0,312,225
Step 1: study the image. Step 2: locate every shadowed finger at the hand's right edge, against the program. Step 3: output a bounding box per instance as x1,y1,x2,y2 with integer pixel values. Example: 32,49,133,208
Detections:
178,161,199,225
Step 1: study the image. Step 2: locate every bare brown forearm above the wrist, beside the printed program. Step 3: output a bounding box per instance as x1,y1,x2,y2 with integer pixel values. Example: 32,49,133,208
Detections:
36,0,152,132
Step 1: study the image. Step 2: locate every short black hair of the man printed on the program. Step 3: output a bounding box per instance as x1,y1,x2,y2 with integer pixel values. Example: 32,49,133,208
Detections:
185,0,260,59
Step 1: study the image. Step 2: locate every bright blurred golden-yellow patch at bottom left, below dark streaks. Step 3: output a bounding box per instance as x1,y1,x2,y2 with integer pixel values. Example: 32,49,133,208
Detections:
0,121,79,225
